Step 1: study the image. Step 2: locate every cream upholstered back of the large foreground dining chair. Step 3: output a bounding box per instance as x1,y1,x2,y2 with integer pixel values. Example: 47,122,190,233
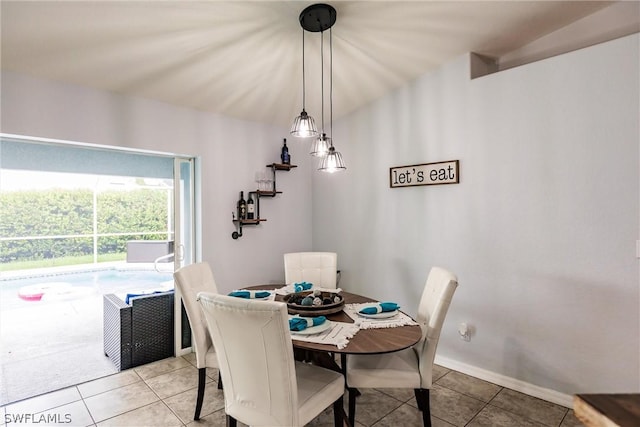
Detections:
199,293,300,426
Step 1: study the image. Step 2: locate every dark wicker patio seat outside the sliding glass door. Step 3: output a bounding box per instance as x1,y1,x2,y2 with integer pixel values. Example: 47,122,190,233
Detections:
103,291,175,371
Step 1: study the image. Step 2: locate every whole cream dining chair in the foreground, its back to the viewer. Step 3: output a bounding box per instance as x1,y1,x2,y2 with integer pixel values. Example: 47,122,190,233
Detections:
198,292,344,427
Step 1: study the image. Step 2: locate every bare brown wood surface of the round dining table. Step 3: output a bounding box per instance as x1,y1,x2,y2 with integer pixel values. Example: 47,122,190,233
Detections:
245,284,422,355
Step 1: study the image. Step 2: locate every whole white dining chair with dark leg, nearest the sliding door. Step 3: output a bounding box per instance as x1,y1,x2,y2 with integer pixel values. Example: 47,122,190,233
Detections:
173,262,222,421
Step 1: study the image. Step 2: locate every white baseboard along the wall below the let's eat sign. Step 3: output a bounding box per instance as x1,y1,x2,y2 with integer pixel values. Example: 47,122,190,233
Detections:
435,355,573,408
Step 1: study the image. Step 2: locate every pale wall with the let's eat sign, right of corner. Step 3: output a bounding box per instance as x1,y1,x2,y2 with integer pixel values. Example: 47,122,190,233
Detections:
313,35,640,404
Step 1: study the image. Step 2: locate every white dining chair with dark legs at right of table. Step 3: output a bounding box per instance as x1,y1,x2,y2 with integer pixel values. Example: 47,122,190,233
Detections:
346,267,458,427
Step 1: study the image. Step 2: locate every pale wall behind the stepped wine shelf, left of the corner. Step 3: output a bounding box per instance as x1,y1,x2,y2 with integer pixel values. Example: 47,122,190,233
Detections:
0,71,313,291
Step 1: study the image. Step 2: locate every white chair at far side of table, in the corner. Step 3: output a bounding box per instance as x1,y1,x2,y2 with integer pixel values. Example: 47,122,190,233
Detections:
284,252,338,289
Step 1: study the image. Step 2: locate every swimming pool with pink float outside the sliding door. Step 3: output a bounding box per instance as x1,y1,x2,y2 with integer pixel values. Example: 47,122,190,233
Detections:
0,267,173,310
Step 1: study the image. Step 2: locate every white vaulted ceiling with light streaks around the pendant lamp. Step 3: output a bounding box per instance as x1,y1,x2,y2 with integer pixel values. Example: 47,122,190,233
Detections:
0,0,632,126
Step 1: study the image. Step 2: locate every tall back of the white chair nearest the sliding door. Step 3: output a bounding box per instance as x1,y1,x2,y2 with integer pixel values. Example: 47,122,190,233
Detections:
173,262,218,368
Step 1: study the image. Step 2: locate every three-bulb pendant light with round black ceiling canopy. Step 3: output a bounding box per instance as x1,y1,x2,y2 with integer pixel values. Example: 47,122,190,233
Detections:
291,3,346,172
